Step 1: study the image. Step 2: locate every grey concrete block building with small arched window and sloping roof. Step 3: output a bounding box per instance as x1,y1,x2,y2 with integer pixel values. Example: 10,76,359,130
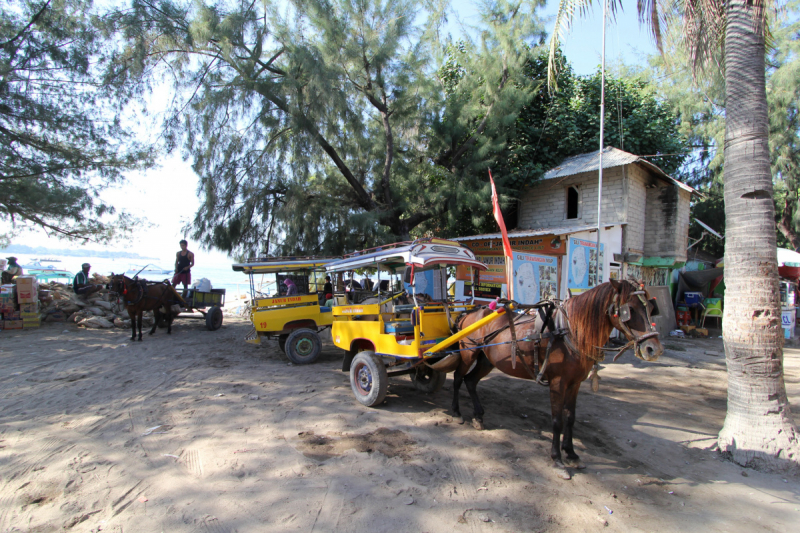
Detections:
457,147,698,318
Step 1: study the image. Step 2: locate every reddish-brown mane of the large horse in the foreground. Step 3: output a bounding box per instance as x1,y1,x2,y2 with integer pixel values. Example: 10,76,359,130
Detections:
564,281,636,360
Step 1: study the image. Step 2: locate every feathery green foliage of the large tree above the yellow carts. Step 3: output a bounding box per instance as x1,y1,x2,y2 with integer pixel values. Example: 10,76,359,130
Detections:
115,0,542,253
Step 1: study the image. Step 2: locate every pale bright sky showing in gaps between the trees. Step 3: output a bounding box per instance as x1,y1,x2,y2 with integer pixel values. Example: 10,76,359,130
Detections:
12,0,656,266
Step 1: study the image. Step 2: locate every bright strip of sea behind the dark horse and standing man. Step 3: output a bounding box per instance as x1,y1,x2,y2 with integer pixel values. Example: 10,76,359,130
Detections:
3,252,266,301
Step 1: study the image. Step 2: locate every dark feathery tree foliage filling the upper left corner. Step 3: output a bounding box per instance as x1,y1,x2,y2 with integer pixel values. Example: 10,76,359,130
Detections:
0,0,147,241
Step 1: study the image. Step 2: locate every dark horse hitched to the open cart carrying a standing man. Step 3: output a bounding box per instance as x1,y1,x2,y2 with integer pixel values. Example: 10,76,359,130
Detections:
108,273,186,341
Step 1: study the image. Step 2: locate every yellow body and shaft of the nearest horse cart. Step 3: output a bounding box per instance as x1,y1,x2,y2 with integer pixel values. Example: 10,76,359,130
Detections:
331,300,505,359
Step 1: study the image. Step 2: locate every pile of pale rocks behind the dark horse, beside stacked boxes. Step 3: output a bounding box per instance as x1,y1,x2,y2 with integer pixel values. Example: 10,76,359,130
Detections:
39,274,153,328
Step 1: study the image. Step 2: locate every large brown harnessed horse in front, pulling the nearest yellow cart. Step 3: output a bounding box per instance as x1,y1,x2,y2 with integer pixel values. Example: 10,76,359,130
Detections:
450,280,664,479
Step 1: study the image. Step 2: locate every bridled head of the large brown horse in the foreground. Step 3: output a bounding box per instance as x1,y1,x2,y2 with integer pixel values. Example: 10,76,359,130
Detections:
607,280,664,361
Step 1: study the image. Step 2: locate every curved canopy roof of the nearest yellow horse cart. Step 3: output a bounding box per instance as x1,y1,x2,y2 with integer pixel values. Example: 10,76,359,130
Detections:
325,238,488,272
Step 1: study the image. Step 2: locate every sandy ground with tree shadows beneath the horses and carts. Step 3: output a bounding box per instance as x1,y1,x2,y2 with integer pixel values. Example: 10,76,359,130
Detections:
0,317,800,533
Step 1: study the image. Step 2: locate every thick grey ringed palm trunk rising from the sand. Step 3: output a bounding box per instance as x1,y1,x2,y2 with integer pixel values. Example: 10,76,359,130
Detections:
719,0,800,470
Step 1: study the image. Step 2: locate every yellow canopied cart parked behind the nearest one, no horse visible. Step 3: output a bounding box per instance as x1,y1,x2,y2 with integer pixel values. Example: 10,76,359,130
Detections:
233,257,336,365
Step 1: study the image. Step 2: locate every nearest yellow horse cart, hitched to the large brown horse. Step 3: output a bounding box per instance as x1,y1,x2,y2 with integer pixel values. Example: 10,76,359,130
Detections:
325,238,504,407
